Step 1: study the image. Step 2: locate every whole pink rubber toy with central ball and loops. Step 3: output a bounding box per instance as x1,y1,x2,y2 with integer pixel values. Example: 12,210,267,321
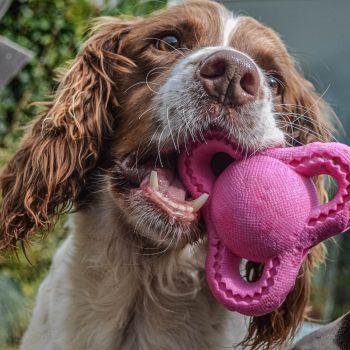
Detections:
179,132,350,316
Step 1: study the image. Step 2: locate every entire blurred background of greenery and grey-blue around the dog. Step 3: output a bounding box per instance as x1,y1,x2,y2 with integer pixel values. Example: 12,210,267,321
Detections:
0,0,350,350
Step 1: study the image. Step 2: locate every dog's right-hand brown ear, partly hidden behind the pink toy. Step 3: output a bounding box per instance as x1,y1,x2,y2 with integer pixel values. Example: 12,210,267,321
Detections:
243,65,333,349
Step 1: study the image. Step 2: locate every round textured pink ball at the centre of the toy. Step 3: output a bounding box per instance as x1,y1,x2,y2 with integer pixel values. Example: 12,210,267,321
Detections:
210,156,316,262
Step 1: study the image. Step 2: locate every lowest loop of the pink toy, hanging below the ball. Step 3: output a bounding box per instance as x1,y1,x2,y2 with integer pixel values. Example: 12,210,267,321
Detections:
206,220,304,316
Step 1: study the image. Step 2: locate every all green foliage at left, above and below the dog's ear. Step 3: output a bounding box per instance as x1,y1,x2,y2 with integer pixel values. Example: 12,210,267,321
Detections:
0,0,166,349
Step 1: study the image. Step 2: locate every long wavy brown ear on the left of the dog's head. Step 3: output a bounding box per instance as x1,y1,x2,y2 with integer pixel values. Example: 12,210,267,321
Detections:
0,17,134,249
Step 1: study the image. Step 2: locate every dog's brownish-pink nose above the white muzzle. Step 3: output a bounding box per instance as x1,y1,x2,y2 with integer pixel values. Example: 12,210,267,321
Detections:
199,50,260,106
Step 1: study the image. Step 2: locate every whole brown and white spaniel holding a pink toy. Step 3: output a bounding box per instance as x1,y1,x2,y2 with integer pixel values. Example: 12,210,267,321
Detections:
0,1,330,350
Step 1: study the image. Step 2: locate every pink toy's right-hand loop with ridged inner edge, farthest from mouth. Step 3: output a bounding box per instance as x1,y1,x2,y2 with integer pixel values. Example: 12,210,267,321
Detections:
266,142,350,247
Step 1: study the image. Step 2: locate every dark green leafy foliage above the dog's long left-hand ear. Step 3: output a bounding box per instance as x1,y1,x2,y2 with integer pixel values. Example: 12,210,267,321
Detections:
0,0,166,144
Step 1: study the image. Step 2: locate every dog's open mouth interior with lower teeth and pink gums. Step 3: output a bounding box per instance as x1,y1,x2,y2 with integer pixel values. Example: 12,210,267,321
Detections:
112,133,241,223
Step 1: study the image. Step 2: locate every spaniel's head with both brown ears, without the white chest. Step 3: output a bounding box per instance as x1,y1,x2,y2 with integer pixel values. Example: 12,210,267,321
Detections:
0,1,329,346
